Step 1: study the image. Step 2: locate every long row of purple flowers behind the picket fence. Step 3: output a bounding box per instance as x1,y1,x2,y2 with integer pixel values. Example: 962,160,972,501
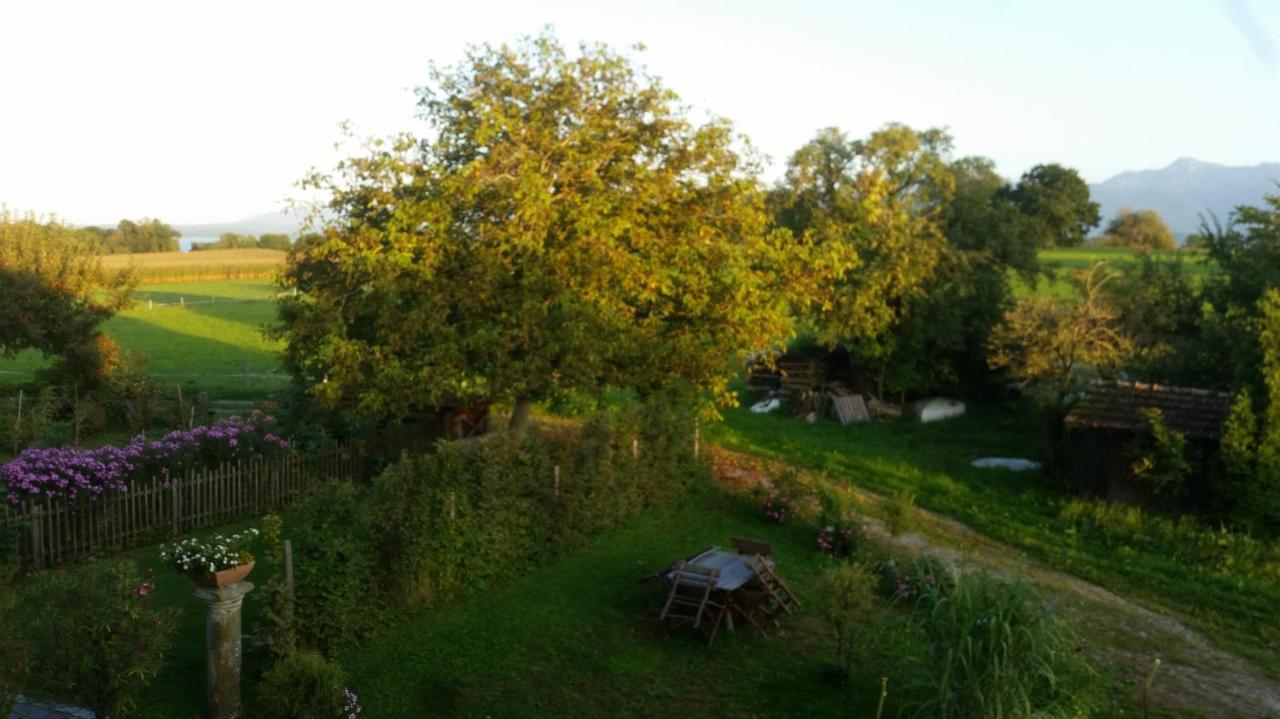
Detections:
0,411,289,504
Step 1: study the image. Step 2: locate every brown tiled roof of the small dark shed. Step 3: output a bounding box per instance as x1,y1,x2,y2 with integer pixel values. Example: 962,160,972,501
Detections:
1065,381,1231,439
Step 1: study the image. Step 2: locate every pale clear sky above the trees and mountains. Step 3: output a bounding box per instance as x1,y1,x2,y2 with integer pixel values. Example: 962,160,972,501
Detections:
0,0,1280,224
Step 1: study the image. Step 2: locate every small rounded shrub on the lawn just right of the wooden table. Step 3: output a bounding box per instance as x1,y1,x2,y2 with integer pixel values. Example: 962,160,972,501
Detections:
814,560,884,676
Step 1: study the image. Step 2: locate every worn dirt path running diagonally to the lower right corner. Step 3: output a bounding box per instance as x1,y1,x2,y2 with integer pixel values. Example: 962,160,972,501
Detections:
713,448,1280,719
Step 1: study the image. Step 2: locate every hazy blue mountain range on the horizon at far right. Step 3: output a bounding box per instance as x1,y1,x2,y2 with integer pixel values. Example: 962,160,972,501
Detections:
1089,157,1280,239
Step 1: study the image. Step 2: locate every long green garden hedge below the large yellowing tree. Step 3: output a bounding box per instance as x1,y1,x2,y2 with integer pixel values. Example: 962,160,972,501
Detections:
287,403,709,651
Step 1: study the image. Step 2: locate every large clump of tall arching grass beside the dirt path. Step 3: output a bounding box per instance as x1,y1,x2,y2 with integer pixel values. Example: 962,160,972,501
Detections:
900,567,1092,719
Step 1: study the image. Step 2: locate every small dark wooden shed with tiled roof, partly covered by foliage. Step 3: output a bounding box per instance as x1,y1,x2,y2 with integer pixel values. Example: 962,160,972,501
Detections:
1062,381,1231,504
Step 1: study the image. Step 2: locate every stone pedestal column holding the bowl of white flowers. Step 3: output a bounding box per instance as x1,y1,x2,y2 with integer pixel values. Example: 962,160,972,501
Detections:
196,582,253,719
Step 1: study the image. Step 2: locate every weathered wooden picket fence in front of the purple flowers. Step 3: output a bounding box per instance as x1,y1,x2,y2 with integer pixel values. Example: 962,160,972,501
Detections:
0,429,429,569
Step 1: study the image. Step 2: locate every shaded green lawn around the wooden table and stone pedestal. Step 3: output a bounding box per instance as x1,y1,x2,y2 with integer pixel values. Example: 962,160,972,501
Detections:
120,490,895,719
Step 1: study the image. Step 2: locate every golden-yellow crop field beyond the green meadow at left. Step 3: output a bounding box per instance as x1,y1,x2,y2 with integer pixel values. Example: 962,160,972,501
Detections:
102,244,284,284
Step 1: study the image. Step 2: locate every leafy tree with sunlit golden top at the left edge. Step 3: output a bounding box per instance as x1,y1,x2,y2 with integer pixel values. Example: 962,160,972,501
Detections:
0,211,133,384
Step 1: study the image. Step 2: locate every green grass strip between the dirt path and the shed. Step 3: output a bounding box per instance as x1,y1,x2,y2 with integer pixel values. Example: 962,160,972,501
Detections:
708,403,1280,678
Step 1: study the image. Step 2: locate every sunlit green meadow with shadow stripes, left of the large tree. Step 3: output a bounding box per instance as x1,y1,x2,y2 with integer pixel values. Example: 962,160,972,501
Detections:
0,278,287,398
